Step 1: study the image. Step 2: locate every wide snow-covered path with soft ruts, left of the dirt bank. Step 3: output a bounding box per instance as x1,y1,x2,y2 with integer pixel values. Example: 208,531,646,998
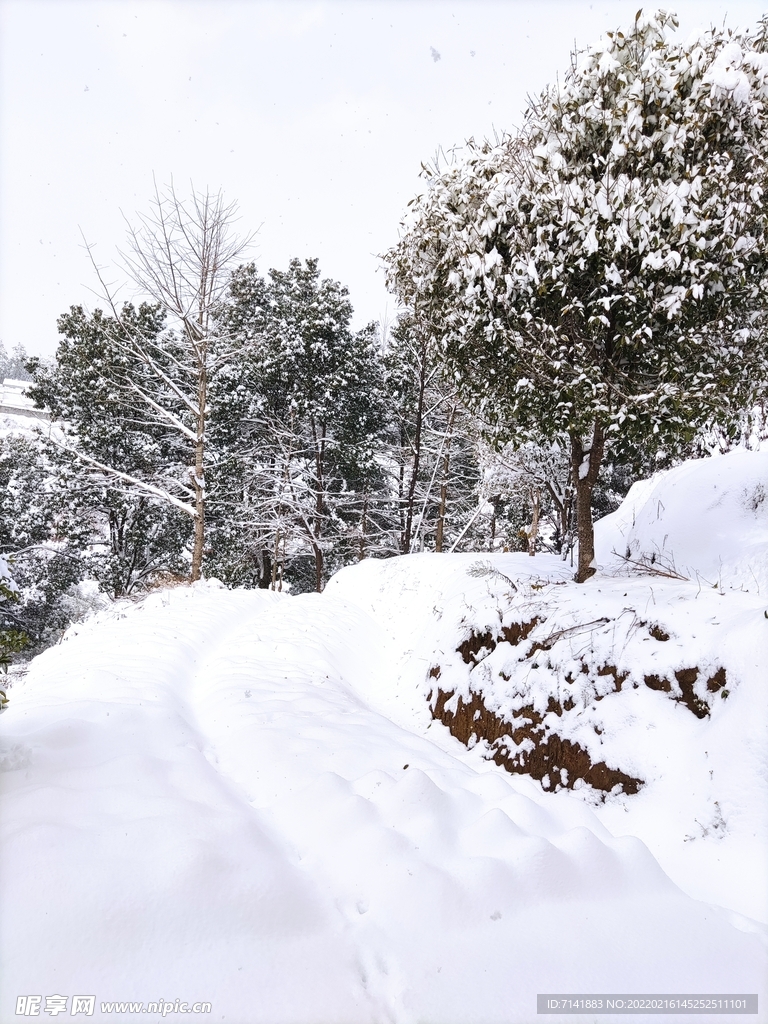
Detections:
0,585,766,1024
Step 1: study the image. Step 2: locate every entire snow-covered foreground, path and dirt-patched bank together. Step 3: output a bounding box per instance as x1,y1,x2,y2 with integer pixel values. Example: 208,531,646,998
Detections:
0,456,768,1024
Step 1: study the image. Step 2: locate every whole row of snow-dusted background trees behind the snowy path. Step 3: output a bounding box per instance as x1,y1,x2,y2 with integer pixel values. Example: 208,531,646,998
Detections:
0,189,606,650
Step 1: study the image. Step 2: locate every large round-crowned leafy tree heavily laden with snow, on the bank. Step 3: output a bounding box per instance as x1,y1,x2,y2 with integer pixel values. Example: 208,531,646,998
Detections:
385,11,768,582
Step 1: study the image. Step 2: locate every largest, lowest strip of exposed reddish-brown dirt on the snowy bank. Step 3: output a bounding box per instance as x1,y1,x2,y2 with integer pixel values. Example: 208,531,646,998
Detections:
430,689,643,794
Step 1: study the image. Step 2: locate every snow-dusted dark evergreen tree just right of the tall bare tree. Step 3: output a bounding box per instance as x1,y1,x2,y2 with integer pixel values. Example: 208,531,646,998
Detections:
222,259,391,591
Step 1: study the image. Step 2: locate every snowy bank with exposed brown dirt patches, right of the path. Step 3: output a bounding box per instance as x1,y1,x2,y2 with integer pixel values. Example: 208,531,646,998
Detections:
329,555,768,922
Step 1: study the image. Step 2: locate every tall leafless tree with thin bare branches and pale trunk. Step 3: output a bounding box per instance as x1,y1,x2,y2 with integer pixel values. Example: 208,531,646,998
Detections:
83,184,251,581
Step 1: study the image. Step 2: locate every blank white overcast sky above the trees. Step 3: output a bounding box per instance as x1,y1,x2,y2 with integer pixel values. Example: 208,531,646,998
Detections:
0,0,764,354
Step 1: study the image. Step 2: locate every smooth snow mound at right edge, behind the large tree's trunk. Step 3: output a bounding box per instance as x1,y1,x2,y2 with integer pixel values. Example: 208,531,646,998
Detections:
595,451,768,595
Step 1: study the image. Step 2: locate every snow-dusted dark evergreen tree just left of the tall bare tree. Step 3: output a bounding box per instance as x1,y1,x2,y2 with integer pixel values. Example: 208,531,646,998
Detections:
29,303,190,597
